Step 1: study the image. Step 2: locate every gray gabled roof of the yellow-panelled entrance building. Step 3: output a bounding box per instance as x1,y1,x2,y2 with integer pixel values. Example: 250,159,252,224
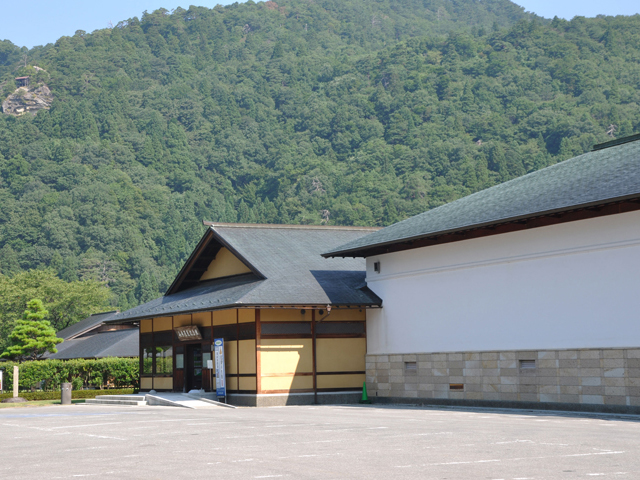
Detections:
110,223,382,322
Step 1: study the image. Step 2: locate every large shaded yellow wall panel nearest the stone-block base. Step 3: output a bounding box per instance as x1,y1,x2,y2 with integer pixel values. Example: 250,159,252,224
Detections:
316,338,367,372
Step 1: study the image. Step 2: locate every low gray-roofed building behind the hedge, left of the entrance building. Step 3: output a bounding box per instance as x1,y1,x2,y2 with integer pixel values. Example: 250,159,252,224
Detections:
45,311,139,360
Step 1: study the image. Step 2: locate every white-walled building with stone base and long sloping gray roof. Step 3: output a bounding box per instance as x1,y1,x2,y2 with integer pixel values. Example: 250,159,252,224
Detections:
324,135,640,412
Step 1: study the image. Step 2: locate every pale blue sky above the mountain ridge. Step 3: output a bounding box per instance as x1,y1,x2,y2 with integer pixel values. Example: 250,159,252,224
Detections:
0,0,640,48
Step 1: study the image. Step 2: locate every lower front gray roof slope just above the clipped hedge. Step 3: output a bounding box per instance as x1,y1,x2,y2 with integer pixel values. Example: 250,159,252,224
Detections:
46,328,140,360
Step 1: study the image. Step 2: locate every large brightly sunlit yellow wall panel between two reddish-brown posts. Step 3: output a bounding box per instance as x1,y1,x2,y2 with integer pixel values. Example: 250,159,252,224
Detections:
259,338,313,373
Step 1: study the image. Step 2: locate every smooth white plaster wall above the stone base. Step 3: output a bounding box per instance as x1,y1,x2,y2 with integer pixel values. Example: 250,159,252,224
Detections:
367,212,640,354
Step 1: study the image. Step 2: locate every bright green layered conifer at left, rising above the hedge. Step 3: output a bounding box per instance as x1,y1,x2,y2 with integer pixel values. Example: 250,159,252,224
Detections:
0,298,63,363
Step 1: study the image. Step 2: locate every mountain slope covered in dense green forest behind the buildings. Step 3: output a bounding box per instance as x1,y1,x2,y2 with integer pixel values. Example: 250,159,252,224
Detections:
0,0,640,308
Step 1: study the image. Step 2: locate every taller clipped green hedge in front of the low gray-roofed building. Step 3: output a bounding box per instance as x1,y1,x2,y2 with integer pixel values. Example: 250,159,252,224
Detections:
0,357,140,392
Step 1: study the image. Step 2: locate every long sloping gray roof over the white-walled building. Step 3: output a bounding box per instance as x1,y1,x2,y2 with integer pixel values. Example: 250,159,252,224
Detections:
323,137,640,257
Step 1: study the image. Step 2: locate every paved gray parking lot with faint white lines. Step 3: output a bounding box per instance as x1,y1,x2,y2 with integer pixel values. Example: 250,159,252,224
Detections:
0,405,640,480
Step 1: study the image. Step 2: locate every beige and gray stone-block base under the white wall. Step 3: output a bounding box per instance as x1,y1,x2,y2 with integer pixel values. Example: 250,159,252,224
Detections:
366,348,640,412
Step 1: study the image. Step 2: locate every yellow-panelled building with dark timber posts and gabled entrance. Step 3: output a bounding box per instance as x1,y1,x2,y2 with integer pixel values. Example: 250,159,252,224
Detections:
110,223,381,405
